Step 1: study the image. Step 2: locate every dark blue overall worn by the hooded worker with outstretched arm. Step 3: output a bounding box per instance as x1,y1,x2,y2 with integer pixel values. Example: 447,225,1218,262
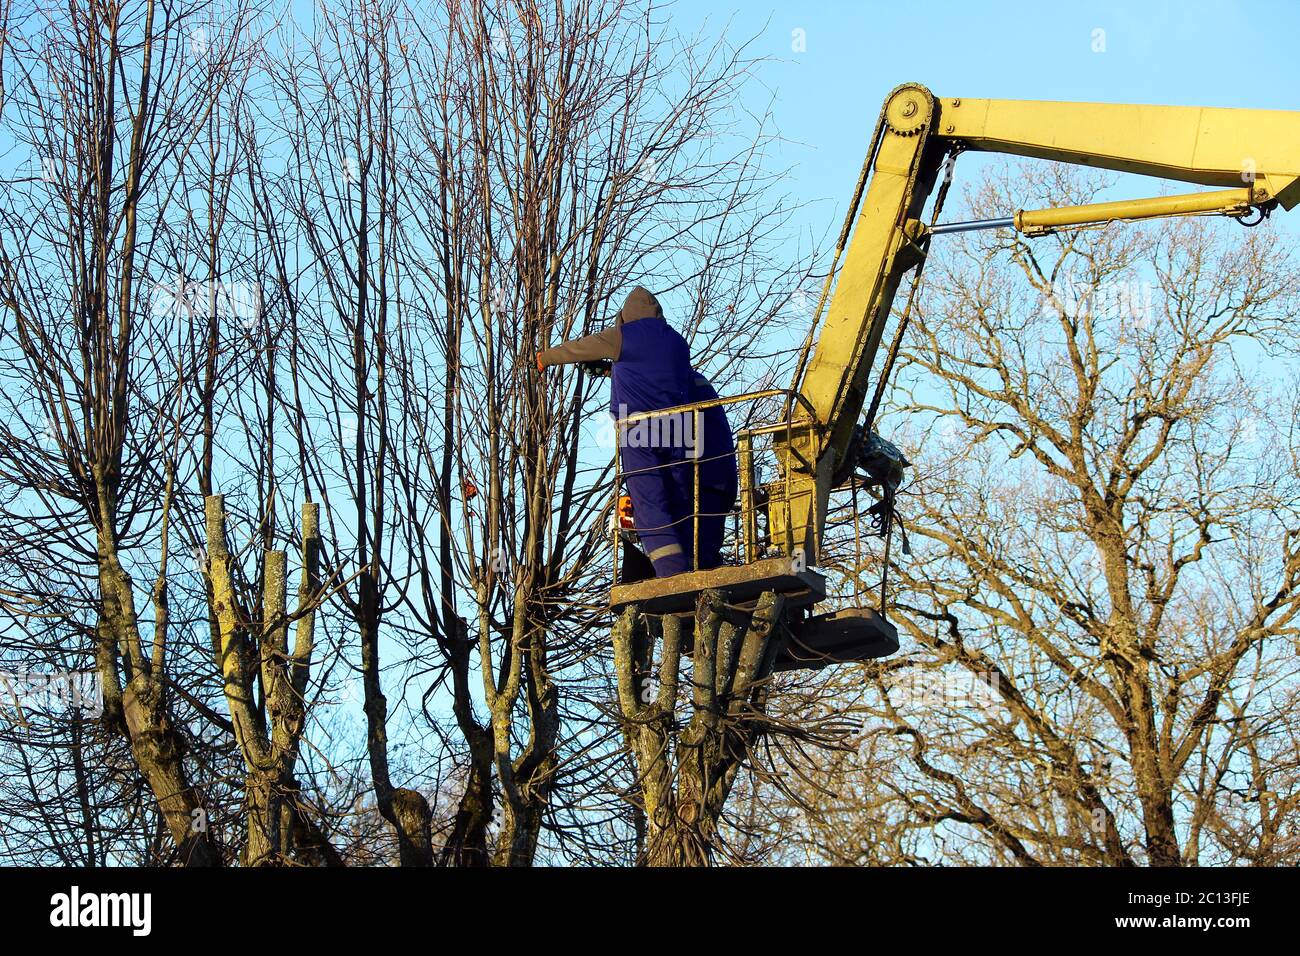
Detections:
610,316,694,578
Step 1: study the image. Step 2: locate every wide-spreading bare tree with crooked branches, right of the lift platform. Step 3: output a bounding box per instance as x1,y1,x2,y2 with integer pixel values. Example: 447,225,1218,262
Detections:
764,166,1300,865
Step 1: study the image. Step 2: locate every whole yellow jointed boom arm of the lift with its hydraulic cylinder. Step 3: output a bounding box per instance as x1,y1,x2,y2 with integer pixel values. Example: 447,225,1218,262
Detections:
768,85,1300,563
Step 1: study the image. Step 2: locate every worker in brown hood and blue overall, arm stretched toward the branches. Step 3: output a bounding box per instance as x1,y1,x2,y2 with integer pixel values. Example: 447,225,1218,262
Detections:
537,286,720,578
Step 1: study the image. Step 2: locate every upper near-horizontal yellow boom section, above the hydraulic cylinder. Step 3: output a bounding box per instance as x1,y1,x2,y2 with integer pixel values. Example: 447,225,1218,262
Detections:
936,98,1300,209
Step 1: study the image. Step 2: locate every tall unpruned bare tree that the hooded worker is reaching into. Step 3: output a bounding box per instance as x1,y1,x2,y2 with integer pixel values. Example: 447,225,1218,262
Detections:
377,3,798,864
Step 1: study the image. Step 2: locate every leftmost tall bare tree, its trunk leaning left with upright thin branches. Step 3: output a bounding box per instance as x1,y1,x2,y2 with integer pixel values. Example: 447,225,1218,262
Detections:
0,3,248,864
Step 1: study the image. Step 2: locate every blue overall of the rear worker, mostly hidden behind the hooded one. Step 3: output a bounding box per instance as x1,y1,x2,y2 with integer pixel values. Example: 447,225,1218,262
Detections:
673,372,737,571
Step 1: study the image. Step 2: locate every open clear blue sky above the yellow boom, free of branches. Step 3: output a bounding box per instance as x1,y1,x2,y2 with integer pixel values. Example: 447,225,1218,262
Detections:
671,0,1300,233
